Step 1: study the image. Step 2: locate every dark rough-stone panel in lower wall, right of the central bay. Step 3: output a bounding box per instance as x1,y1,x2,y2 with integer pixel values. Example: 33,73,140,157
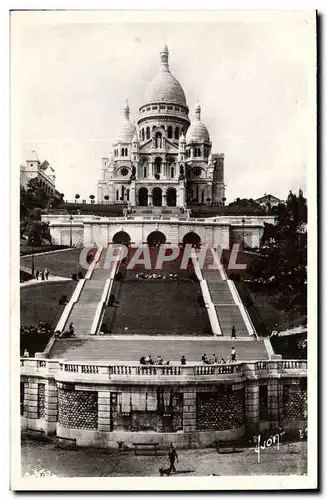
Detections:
196,389,244,431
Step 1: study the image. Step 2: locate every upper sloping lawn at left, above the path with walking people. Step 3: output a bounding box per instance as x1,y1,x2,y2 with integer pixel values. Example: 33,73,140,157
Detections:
20,248,87,278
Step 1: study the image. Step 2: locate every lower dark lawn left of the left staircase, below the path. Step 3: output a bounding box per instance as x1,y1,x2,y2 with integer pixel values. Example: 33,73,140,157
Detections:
20,281,77,327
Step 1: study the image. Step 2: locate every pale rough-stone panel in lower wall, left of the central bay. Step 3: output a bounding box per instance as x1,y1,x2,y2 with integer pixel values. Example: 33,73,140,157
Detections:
58,389,98,429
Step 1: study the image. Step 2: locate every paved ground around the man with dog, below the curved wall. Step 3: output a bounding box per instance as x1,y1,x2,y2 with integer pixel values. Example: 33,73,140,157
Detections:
22,440,307,479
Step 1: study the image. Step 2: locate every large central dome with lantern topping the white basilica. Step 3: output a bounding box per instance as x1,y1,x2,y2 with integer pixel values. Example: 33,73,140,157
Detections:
145,45,187,106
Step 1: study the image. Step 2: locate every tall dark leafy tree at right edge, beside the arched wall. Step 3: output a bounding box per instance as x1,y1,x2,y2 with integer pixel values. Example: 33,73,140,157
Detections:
249,190,307,314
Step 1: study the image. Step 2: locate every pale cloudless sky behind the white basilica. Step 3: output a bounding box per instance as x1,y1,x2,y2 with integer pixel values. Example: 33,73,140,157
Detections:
11,11,315,202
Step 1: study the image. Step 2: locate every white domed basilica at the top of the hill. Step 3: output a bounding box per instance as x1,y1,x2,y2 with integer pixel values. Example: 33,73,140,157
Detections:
98,46,225,207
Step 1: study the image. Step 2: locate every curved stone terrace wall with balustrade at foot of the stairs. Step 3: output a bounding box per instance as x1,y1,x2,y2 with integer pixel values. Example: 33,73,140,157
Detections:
21,358,307,448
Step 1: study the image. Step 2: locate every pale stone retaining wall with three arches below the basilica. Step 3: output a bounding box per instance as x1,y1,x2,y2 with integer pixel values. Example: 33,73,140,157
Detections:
42,215,274,248
